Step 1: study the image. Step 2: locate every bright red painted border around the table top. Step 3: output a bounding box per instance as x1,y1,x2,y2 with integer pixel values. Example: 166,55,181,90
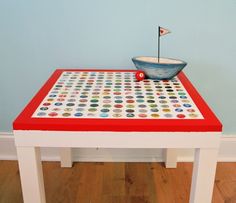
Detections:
13,69,222,132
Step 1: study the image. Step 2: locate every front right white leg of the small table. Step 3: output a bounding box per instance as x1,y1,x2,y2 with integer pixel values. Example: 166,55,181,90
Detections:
190,148,218,203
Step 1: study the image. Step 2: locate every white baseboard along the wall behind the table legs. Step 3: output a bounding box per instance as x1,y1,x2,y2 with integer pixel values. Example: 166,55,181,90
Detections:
0,132,236,162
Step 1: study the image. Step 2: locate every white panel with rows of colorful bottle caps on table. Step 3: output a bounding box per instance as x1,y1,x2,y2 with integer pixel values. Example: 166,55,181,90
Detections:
32,71,203,119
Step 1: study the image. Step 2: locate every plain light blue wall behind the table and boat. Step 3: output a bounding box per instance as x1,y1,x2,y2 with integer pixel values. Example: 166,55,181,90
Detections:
0,0,236,134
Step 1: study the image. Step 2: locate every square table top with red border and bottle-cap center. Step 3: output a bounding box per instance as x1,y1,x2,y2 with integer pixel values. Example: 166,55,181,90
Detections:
13,69,222,132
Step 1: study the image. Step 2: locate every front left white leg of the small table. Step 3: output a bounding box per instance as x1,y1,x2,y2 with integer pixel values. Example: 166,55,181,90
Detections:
17,147,46,203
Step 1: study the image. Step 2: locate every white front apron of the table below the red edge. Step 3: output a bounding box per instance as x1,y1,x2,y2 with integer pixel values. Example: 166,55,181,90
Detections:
14,130,221,148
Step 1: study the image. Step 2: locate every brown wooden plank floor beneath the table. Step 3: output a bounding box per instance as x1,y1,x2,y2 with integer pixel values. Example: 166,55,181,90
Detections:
0,161,236,203
